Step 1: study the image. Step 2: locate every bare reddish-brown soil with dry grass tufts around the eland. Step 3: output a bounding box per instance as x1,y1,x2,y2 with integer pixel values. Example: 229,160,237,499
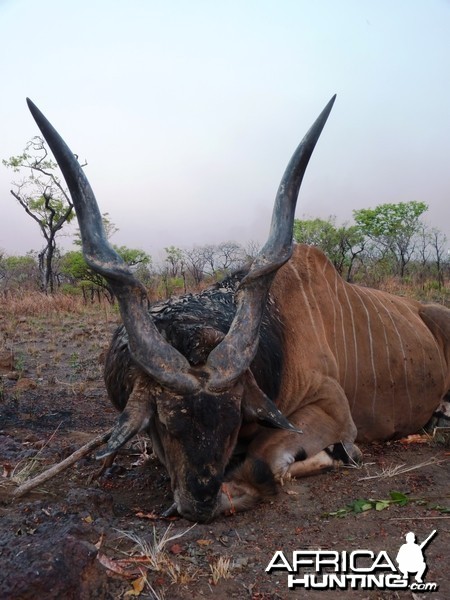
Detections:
0,312,450,600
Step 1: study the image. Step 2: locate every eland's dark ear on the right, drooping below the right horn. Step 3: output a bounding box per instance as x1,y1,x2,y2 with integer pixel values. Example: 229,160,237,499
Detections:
241,370,303,433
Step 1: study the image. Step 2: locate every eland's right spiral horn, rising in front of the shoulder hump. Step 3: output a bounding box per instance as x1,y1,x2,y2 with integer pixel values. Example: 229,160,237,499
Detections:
207,96,336,391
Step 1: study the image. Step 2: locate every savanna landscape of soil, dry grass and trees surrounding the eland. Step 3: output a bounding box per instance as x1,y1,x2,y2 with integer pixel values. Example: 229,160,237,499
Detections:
0,137,450,600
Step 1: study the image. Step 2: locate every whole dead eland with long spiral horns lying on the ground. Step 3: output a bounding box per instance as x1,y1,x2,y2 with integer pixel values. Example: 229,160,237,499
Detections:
29,98,450,521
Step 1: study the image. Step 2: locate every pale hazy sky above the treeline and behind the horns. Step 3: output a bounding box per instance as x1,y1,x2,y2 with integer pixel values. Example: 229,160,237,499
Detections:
0,0,450,257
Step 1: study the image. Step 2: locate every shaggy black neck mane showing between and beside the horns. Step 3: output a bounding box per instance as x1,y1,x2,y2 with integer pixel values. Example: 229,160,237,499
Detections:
105,268,283,406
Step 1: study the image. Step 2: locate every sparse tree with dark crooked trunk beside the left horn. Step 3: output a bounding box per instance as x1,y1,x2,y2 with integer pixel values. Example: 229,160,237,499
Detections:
2,136,79,292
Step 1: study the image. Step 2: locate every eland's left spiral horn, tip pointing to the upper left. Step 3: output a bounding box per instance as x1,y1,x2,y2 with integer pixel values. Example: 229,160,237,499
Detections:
27,98,200,393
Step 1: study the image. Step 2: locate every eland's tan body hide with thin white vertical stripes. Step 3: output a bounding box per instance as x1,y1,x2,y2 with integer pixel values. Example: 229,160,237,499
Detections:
271,245,450,455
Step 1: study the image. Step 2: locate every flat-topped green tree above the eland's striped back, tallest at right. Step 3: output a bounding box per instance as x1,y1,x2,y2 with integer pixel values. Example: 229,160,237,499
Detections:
353,201,428,278
